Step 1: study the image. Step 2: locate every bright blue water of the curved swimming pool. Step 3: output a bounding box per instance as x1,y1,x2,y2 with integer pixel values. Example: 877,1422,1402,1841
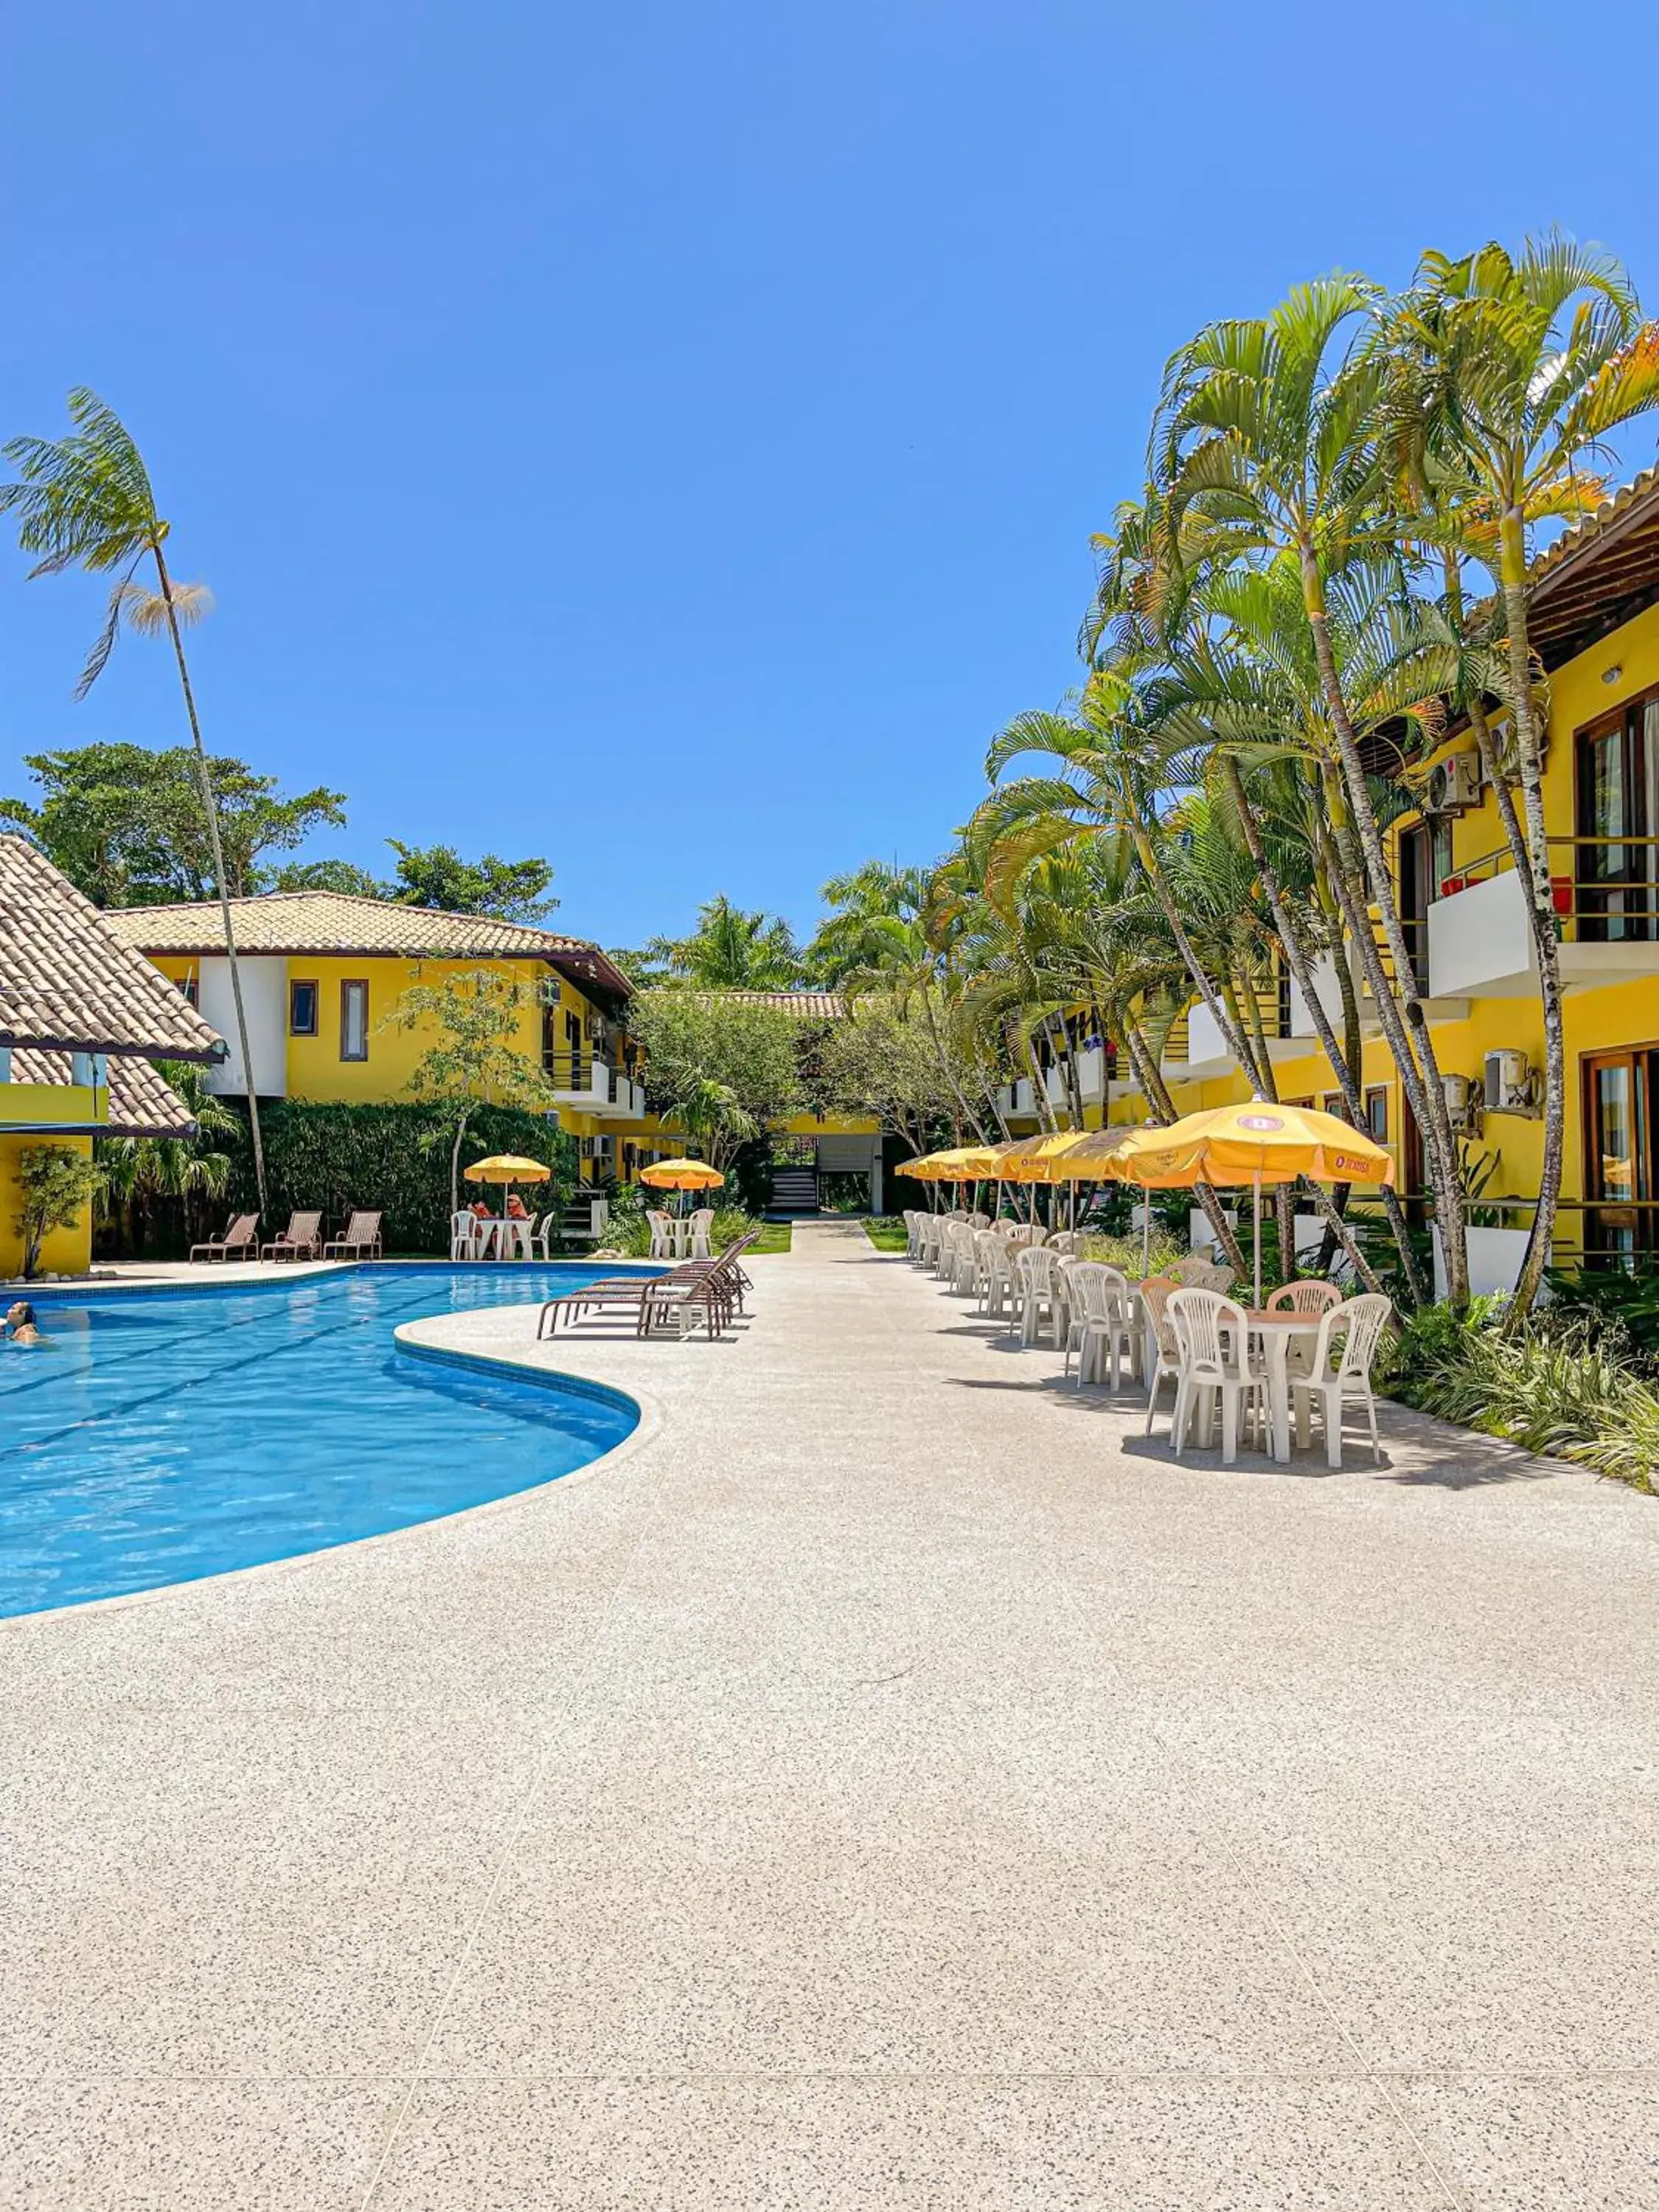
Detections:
0,1265,655,1615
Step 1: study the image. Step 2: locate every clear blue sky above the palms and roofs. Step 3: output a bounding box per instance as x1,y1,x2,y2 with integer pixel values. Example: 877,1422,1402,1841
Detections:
0,0,1659,945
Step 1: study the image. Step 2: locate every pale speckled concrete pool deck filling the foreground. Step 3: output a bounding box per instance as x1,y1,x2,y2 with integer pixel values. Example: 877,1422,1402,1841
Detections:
0,1223,1659,2212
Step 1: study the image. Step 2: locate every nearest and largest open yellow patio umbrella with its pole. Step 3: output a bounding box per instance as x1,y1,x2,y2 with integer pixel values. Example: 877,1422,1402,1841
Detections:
1117,1099,1394,1305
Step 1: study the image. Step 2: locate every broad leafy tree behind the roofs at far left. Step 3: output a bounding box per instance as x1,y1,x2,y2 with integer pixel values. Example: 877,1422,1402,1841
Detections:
0,743,345,907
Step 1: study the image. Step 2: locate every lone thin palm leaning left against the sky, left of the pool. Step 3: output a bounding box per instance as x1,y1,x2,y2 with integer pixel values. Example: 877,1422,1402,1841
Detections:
0,385,265,1212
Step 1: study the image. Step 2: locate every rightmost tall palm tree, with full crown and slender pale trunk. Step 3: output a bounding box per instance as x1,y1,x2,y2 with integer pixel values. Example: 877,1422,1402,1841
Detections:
1380,232,1659,1316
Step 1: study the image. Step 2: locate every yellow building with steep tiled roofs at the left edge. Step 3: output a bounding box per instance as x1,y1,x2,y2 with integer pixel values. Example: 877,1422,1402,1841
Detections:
0,836,223,1276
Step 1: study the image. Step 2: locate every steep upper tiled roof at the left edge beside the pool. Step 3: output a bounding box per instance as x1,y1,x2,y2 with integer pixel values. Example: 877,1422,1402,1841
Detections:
0,834,223,1060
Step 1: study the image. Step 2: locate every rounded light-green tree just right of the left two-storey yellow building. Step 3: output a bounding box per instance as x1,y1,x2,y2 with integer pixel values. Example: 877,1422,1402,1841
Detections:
628,989,805,1166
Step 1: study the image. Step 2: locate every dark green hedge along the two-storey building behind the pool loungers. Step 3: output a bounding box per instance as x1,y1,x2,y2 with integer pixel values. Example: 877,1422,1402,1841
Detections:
226,1099,577,1252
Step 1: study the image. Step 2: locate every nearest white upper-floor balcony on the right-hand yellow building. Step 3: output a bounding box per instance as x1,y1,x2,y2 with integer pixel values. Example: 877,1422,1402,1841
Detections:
1427,836,1659,1000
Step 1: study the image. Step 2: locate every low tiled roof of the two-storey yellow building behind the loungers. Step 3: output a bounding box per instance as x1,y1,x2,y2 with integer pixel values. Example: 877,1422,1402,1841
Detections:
111,891,593,960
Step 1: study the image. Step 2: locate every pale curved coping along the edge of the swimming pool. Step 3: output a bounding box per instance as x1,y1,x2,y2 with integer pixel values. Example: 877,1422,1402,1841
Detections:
0,1292,664,1637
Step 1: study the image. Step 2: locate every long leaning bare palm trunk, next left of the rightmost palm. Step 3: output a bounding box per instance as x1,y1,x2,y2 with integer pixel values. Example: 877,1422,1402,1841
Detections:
1301,557,1469,1305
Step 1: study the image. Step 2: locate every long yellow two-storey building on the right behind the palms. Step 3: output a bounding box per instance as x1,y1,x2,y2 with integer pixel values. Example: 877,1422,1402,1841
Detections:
1006,471,1659,1287
